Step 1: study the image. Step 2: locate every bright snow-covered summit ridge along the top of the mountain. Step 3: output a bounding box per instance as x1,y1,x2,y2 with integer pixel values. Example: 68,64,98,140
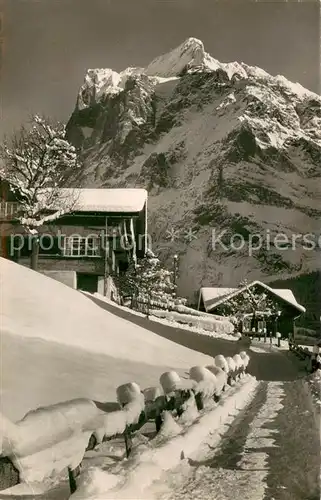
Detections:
77,37,319,110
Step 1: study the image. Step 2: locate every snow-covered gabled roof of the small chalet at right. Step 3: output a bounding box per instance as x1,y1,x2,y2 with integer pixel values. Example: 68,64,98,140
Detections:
200,281,306,312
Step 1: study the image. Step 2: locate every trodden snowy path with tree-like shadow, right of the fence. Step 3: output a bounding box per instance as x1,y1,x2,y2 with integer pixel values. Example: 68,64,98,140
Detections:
145,368,320,500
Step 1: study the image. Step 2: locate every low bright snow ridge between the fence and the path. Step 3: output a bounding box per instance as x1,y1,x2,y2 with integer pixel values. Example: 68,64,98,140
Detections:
71,375,258,500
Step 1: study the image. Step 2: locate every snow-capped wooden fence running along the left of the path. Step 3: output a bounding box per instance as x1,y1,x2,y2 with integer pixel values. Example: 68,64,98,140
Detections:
0,354,247,493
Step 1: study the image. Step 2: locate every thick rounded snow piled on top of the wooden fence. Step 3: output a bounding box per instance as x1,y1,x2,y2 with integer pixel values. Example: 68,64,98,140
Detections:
0,346,252,483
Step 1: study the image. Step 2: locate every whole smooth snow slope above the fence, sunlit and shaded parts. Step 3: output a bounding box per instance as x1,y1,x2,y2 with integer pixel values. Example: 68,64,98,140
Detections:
0,259,212,420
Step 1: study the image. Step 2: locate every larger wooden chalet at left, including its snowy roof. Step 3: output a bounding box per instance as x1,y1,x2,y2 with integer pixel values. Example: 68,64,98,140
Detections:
0,182,147,295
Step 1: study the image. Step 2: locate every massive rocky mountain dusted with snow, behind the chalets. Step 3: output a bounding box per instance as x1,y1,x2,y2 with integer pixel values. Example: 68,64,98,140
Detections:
67,38,321,300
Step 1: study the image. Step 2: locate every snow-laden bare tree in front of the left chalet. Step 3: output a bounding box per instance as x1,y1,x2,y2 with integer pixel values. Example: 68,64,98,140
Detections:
0,115,81,269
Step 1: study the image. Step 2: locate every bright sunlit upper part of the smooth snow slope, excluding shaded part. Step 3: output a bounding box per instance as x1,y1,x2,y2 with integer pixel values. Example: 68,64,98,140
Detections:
0,258,210,370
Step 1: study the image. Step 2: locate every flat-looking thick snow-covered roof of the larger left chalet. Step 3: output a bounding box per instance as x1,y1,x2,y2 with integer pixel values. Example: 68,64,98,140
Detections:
57,188,147,212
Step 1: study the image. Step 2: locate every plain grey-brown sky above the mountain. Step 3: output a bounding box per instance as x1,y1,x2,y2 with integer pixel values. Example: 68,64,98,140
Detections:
0,0,320,136
